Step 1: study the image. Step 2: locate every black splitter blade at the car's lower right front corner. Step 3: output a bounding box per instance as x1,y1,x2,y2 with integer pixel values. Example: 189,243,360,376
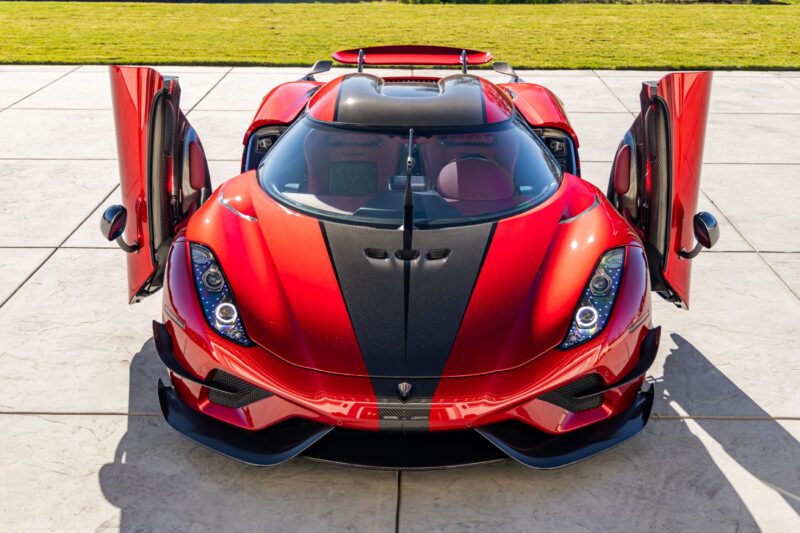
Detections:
476,385,655,469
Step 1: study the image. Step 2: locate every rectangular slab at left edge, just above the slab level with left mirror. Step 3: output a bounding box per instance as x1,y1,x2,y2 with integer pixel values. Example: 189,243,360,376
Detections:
0,109,117,160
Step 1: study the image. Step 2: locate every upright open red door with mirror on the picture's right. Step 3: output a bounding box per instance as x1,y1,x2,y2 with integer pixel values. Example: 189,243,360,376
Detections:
608,72,719,308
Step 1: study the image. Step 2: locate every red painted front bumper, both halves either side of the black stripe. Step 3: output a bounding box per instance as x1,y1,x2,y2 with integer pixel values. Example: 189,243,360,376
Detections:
164,207,650,433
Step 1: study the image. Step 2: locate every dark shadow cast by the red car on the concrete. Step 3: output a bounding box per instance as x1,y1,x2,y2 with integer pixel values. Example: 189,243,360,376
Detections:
99,335,800,532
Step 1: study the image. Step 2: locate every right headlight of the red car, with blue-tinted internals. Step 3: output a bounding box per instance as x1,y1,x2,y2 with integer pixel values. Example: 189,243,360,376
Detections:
559,248,625,349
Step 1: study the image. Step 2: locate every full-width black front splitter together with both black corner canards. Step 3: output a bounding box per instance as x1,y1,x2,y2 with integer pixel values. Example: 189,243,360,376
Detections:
154,318,659,469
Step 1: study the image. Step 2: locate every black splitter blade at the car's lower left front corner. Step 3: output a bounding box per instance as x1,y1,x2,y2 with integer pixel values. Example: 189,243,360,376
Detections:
158,380,333,466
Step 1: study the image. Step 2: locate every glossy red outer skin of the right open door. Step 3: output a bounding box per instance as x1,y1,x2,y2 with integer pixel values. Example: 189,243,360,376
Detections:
658,72,712,308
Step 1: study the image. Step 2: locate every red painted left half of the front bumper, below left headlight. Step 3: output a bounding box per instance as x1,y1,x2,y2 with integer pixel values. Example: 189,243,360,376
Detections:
163,235,377,429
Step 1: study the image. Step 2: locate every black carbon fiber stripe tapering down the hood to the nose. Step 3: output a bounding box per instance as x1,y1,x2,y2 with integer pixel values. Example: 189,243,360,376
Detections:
321,222,493,429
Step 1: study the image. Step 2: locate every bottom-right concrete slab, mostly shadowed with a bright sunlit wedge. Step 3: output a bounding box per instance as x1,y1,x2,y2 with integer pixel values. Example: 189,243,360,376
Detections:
399,420,800,531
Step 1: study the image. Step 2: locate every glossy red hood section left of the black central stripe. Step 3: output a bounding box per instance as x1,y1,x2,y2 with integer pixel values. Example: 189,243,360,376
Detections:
186,172,367,375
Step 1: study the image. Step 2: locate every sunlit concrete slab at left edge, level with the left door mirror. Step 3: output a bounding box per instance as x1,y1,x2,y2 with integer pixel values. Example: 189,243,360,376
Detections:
0,159,119,247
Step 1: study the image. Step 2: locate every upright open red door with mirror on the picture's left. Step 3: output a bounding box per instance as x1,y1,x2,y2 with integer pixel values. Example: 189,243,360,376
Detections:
101,66,211,303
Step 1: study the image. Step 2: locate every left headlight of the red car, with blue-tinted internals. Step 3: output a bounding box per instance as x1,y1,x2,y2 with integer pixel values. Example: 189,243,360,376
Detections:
190,243,253,346
